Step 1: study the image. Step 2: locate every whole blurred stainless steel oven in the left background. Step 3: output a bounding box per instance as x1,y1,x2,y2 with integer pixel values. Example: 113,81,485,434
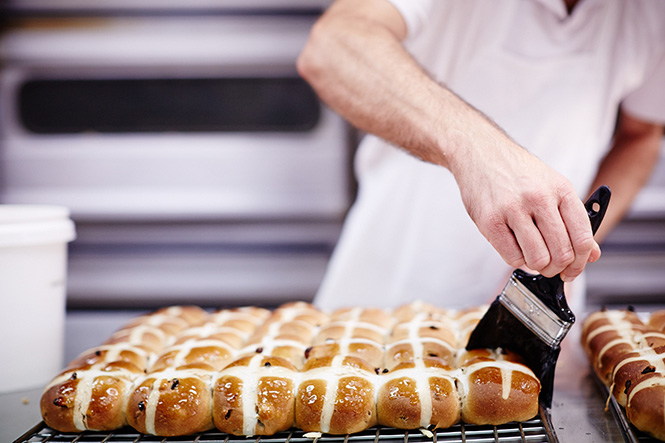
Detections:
0,0,353,306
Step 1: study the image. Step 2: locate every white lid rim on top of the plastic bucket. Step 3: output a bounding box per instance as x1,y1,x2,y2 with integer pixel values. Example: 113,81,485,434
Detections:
0,205,76,247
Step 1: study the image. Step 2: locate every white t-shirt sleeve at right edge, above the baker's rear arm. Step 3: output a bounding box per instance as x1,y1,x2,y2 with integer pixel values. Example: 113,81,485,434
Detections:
622,52,665,123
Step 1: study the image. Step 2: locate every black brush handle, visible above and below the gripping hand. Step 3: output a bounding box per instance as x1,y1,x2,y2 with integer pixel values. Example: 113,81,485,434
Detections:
513,185,612,323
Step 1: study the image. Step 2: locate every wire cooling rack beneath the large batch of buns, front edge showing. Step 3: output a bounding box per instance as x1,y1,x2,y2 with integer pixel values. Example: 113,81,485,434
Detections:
14,407,559,443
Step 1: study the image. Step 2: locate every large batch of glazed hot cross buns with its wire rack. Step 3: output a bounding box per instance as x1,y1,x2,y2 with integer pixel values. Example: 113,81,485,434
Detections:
19,302,557,443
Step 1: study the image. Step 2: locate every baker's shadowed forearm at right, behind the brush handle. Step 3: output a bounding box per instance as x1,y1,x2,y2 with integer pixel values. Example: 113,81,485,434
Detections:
591,113,663,242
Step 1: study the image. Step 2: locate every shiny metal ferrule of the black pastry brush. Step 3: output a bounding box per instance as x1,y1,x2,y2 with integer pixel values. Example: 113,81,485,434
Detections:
498,276,573,348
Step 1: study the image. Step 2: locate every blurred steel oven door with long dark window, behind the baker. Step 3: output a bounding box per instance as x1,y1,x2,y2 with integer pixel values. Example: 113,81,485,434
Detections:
0,16,348,220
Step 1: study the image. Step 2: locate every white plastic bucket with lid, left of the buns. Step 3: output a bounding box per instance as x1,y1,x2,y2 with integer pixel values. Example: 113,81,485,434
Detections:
0,205,76,392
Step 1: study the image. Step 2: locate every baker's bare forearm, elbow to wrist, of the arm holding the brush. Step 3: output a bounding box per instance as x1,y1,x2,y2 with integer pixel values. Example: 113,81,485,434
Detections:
298,1,508,176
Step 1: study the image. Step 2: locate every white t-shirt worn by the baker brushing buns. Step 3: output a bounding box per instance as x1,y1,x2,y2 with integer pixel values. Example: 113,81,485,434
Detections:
315,0,665,309
